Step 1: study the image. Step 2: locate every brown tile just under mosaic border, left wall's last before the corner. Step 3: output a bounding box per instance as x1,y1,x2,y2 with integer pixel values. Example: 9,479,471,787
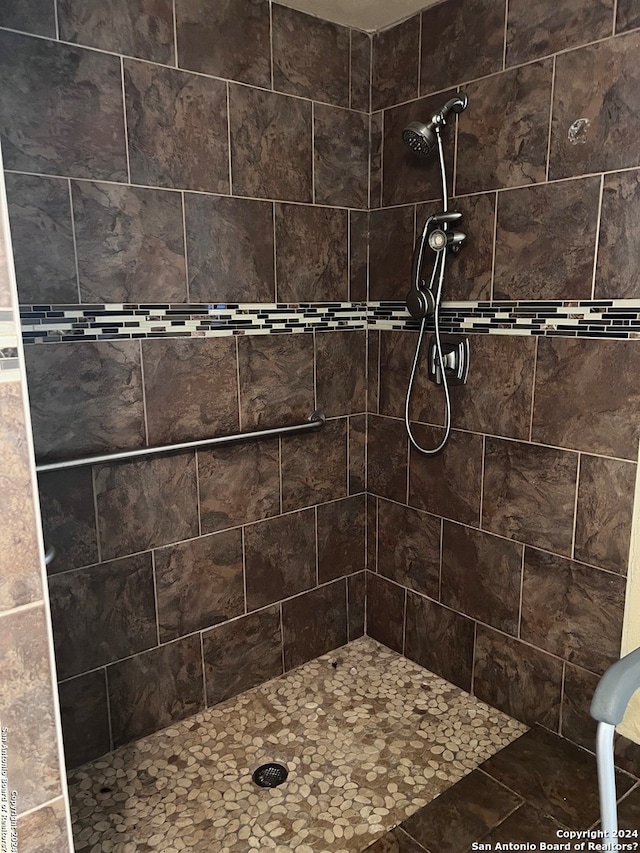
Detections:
316,331,367,418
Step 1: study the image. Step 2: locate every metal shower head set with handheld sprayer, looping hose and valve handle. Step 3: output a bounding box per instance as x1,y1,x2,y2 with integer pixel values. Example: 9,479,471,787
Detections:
402,92,469,456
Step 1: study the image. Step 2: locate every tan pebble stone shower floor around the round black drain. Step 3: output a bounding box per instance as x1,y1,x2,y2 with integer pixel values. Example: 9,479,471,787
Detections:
69,637,527,853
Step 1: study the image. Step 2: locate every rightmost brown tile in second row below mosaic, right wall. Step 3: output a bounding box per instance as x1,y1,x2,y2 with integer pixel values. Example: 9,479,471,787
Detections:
574,456,636,575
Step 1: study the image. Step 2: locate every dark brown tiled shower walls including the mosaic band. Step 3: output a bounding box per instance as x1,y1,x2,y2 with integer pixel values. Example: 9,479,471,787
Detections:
0,0,640,849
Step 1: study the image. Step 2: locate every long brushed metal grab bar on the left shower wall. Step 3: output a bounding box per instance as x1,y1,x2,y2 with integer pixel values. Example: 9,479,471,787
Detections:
36,412,326,474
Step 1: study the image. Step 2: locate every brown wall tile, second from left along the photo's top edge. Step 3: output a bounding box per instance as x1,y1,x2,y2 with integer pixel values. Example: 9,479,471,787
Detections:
58,0,174,65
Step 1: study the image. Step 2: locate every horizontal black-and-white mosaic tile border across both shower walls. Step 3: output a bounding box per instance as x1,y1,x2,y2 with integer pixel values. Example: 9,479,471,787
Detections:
20,299,640,344
